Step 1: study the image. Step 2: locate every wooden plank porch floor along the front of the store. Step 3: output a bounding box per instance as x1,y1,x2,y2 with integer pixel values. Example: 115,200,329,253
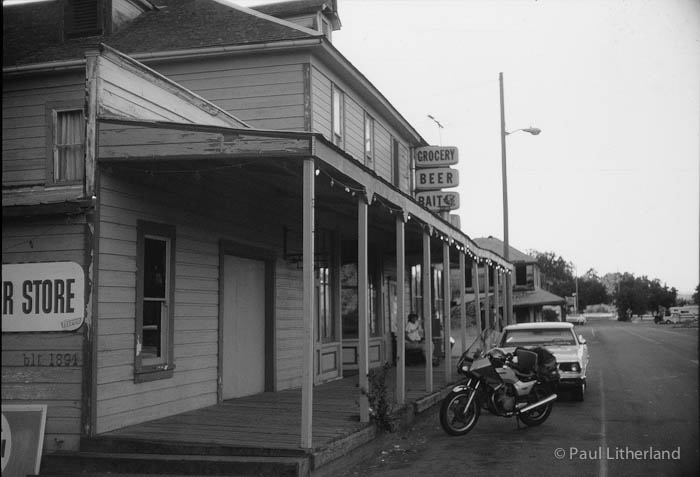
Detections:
81,358,456,469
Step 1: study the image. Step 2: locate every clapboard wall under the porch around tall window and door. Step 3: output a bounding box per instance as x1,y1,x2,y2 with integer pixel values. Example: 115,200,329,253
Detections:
97,171,303,433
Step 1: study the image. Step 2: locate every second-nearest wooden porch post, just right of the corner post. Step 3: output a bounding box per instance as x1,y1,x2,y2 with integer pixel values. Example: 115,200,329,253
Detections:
357,195,369,422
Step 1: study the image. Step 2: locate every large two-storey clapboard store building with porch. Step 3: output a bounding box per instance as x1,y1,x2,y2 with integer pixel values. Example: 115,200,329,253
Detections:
2,0,511,452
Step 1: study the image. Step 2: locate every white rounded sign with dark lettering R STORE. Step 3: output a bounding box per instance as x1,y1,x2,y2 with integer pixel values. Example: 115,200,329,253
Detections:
2,262,85,332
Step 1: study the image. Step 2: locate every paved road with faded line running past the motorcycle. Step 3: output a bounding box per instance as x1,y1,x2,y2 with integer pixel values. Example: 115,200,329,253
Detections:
324,321,699,477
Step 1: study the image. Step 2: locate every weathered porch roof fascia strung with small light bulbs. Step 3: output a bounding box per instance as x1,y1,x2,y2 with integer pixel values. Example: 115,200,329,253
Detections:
96,117,513,270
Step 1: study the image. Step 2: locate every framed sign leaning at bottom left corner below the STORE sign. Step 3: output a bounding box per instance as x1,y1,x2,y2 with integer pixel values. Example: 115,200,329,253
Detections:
2,404,46,477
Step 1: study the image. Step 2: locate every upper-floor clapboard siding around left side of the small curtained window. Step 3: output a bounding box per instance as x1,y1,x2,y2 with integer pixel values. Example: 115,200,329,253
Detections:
2,71,85,188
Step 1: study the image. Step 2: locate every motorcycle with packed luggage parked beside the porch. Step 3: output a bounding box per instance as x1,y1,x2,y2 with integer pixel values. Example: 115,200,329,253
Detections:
440,334,559,436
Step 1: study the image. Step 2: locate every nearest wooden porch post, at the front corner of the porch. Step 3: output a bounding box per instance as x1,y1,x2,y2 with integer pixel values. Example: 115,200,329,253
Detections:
301,159,316,449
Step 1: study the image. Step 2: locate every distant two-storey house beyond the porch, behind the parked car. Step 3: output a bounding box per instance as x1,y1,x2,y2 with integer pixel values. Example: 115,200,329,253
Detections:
474,236,566,323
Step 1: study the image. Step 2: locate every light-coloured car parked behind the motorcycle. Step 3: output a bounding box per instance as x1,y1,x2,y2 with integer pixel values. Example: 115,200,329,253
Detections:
499,322,589,401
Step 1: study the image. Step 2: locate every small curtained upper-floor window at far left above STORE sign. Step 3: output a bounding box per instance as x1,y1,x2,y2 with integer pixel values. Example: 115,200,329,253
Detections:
53,109,85,183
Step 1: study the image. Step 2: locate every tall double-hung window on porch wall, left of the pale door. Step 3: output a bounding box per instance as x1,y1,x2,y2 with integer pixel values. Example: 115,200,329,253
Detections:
135,221,175,382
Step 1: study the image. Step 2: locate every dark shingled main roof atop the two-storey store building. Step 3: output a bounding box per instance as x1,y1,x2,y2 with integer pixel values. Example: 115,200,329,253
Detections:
3,0,323,66
